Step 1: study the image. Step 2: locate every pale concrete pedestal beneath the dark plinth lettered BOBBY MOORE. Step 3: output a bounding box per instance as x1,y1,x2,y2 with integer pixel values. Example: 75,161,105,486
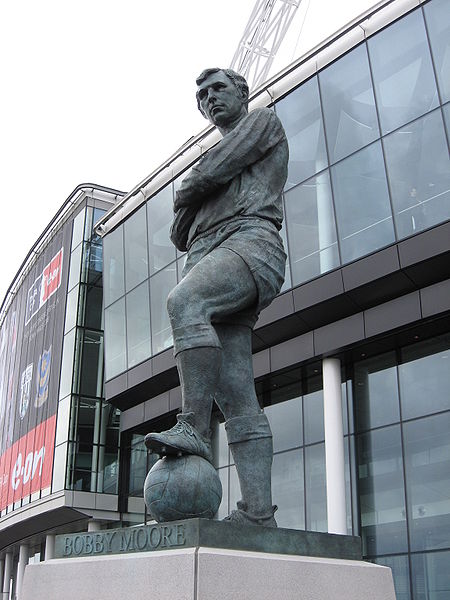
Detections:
21,547,395,600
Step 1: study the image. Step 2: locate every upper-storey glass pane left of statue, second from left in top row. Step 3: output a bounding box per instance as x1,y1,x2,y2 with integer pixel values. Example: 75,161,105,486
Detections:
124,206,148,291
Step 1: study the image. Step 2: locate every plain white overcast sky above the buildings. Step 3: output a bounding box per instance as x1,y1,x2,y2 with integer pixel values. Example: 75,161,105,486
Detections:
0,0,376,302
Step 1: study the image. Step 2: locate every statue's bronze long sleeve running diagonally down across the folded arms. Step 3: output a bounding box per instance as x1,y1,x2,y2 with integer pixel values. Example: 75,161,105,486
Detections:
174,108,286,211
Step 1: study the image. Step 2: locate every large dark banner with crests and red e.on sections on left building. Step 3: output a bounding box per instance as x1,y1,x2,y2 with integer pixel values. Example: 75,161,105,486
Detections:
0,221,72,510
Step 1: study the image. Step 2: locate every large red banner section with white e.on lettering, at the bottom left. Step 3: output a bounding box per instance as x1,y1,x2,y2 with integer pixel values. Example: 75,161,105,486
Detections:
0,415,56,510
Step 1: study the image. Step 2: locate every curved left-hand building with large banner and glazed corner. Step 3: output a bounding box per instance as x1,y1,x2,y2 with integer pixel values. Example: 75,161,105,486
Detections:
0,184,123,600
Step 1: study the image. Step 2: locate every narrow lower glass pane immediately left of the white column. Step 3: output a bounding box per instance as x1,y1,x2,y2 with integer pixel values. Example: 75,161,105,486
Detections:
305,444,328,532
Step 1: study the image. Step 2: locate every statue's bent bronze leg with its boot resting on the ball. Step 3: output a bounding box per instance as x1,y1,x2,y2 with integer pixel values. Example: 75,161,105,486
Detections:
145,248,257,460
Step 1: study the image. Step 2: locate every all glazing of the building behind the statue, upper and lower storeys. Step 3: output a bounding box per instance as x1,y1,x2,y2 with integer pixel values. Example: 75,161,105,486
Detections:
98,0,450,600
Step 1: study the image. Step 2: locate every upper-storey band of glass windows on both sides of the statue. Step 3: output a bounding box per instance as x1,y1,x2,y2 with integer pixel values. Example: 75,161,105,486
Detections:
103,0,450,380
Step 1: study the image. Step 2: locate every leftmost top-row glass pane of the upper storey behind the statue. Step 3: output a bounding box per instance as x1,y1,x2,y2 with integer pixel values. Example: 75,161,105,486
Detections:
103,226,125,306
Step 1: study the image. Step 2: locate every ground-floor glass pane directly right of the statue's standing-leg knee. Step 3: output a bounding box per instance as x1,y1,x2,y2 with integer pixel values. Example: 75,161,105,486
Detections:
264,397,303,452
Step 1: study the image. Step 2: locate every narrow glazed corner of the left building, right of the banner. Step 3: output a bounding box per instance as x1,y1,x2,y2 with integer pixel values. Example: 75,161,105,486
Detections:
52,206,123,494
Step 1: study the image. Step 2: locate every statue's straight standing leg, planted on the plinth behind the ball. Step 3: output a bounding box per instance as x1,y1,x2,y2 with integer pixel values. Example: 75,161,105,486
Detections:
216,325,277,527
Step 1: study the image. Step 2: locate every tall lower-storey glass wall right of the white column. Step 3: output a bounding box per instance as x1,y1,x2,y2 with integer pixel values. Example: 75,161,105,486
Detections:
354,334,450,600
